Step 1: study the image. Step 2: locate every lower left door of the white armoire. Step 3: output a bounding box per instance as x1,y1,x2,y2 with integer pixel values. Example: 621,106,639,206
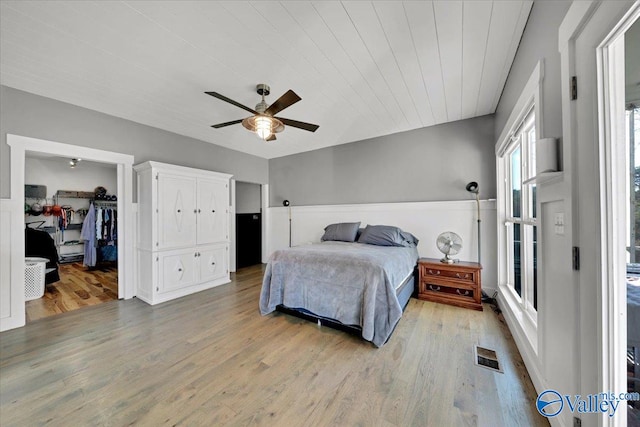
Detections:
158,248,198,293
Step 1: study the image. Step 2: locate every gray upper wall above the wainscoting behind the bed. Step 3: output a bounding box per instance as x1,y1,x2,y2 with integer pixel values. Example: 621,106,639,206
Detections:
269,116,496,206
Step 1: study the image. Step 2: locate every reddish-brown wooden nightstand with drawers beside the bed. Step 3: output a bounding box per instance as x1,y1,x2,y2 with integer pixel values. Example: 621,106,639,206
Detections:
418,258,482,311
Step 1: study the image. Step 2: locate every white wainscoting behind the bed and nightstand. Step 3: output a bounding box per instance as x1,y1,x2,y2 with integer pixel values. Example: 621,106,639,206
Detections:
268,200,497,295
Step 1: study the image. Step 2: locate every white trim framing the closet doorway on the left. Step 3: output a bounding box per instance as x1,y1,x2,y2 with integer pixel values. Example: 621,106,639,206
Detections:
7,134,135,327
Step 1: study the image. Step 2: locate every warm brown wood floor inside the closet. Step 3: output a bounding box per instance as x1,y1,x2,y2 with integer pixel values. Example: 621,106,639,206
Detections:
25,262,118,322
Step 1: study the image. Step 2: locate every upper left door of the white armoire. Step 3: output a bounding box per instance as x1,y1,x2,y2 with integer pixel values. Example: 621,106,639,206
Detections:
156,174,196,249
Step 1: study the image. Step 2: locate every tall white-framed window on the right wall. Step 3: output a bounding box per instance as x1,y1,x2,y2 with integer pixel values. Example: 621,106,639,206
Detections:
499,108,538,320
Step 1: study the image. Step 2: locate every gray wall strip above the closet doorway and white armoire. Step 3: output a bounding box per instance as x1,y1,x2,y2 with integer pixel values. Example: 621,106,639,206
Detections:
0,86,269,198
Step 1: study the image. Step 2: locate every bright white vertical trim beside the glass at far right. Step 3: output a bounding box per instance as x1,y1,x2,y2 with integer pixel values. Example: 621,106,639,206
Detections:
596,2,640,427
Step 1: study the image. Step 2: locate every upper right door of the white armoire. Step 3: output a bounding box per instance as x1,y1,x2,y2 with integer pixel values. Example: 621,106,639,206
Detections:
197,178,229,244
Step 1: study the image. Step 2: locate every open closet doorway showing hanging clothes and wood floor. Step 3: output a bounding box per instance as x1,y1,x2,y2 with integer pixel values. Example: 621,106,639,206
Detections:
25,152,118,323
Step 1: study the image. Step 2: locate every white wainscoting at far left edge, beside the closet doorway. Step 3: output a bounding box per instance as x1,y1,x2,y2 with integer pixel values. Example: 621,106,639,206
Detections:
0,199,25,331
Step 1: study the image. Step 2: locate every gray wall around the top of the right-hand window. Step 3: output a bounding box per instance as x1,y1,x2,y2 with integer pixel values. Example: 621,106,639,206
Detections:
495,1,571,145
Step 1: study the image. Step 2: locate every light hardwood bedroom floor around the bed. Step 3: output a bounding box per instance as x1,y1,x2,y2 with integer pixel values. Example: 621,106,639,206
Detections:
0,266,548,427
